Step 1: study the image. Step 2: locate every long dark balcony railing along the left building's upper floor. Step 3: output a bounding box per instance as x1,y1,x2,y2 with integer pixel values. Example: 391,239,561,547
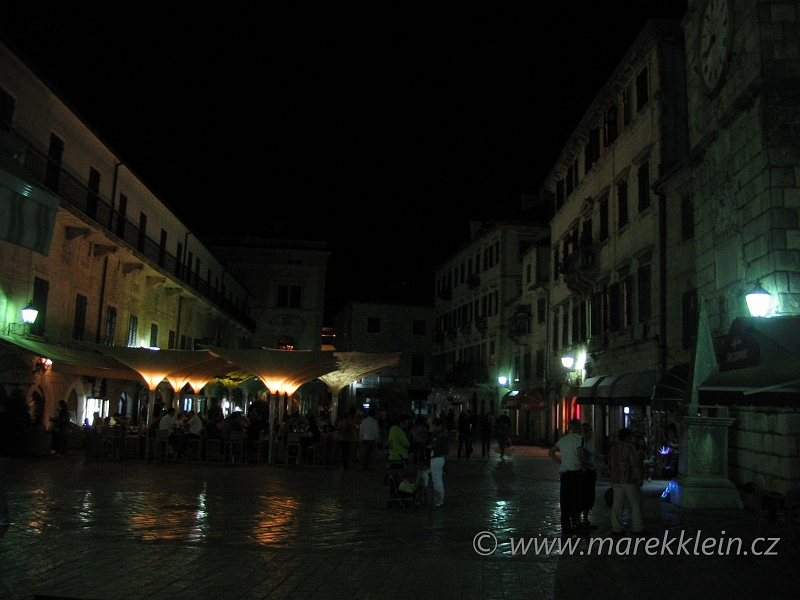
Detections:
11,131,255,331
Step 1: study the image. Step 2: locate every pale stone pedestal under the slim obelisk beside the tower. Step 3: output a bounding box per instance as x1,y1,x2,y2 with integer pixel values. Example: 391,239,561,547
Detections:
670,417,742,509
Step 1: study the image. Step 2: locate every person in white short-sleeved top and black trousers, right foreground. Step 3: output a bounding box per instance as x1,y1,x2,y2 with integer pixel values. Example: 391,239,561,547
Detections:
548,419,584,535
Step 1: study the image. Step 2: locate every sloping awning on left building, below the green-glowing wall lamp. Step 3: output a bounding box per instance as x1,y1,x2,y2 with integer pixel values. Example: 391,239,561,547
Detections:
0,334,142,381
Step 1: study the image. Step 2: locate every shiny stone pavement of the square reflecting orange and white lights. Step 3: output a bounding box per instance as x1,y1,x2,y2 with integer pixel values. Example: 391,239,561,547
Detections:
0,446,800,600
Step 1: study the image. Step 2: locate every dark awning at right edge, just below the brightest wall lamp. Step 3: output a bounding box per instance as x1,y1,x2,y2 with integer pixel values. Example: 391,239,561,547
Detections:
698,317,800,406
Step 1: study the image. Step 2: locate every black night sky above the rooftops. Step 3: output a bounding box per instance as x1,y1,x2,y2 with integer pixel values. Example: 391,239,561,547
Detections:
0,0,686,326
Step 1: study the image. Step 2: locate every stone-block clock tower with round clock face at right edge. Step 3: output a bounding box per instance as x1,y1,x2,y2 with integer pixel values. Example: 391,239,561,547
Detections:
683,0,800,328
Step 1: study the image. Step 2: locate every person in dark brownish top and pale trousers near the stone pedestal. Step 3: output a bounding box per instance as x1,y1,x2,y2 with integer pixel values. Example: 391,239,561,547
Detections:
608,427,644,535
